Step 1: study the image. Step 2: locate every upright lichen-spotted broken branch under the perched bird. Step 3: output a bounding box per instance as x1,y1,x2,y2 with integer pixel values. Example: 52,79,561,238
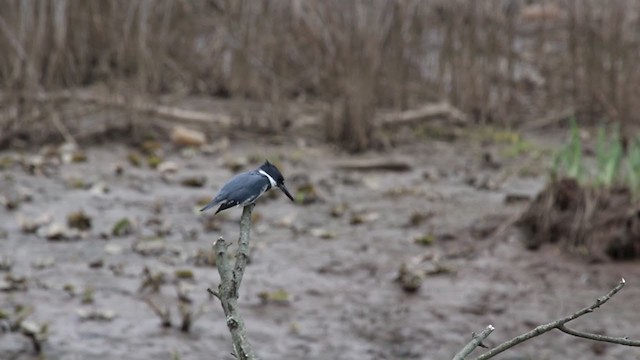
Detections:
208,204,257,360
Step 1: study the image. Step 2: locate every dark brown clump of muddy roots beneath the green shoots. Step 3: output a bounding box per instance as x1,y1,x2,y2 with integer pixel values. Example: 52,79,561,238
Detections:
516,178,640,260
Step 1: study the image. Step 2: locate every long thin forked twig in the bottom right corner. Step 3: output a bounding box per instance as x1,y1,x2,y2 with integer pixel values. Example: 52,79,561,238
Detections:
455,279,639,360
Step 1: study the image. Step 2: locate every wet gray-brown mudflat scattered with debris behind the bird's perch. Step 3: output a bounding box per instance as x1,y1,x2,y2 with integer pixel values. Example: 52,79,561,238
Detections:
0,129,640,360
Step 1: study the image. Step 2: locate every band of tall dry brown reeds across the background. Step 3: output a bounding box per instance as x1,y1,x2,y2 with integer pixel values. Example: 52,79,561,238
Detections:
0,0,640,150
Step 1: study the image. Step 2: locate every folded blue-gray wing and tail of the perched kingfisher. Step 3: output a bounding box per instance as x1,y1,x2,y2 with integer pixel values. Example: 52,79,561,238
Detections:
200,171,269,211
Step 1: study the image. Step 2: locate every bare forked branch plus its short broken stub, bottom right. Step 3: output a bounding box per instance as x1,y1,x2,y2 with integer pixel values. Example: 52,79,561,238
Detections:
454,279,640,360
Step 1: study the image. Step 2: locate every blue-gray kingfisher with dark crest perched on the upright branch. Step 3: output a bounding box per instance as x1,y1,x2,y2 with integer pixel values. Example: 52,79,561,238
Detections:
200,160,294,214
